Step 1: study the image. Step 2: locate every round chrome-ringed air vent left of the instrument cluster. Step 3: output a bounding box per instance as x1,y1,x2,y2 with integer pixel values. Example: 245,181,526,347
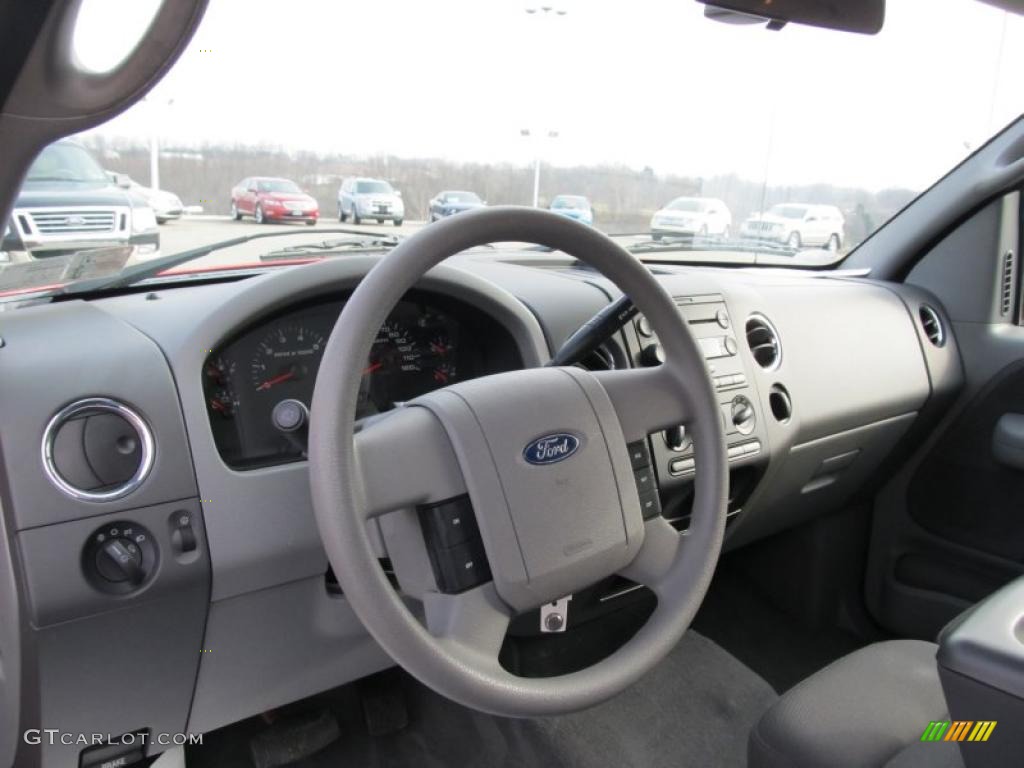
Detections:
42,397,154,502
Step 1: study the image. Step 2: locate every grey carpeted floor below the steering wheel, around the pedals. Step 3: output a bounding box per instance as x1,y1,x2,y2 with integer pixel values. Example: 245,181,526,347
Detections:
188,631,775,768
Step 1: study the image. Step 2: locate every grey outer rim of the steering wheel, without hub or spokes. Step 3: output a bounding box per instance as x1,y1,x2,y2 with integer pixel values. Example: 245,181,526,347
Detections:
309,207,728,717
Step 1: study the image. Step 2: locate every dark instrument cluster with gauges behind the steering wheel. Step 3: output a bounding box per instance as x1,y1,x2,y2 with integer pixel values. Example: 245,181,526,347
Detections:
203,292,521,469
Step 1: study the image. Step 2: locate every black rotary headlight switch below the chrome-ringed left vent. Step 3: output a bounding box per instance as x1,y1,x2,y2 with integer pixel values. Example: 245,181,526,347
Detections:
82,521,158,594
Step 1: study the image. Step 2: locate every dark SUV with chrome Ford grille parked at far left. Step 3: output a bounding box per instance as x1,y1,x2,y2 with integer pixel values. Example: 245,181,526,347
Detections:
0,139,160,262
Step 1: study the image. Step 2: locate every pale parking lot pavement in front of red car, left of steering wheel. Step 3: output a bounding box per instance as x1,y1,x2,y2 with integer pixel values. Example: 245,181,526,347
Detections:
160,216,424,267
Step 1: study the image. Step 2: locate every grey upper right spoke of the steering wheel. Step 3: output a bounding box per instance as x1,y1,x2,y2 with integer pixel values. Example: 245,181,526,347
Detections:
594,366,693,442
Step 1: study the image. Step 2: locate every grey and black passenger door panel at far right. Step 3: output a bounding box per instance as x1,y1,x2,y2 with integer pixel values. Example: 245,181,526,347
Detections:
865,191,1024,639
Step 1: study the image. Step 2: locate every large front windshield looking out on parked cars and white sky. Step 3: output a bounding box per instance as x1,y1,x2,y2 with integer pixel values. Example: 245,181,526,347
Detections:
0,0,1024,292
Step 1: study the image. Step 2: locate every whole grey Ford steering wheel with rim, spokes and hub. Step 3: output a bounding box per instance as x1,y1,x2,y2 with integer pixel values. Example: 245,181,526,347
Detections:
309,207,728,717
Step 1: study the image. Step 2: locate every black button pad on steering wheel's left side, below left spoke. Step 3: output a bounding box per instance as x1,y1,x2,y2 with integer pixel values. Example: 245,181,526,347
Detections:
419,496,490,594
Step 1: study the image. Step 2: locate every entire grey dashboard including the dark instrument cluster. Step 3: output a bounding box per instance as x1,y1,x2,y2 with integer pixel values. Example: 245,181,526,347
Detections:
0,249,963,765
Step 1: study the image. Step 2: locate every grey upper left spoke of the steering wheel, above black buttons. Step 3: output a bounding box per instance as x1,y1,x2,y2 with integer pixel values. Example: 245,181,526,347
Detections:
354,406,466,518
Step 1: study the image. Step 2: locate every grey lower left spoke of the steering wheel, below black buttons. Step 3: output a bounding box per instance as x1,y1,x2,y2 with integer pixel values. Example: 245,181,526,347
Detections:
423,582,511,665
